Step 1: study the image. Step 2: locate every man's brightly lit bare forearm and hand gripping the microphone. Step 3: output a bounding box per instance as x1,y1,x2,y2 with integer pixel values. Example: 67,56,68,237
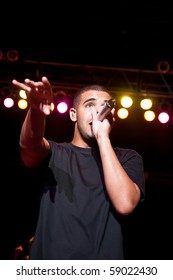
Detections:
92,108,143,215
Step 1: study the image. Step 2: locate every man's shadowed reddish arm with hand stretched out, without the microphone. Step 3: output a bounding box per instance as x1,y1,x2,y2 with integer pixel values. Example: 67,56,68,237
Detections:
12,77,53,167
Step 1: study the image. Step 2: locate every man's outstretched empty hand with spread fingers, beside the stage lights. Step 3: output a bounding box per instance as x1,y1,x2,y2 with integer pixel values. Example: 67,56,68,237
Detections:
12,77,53,115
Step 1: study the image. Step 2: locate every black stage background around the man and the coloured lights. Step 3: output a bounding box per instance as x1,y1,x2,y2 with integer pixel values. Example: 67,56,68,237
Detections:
0,1,173,259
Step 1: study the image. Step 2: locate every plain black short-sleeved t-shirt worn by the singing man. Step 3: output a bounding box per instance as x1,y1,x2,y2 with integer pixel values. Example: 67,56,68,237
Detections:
30,141,145,260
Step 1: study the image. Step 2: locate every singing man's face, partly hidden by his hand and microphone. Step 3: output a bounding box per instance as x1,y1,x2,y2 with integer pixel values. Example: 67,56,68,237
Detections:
76,90,111,140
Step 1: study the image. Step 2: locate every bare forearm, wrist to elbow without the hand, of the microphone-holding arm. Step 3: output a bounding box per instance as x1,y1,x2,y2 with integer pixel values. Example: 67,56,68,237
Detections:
98,137,141,215
